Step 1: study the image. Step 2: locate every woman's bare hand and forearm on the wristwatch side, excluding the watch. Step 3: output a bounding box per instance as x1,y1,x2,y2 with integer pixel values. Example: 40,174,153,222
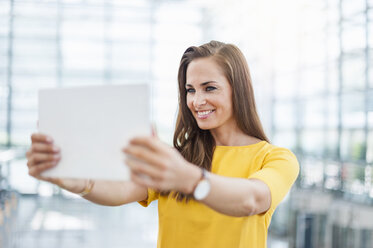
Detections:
124,137,271,216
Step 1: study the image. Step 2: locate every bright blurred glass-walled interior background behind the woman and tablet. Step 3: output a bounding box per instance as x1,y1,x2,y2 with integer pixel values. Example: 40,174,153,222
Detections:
0,0,373,248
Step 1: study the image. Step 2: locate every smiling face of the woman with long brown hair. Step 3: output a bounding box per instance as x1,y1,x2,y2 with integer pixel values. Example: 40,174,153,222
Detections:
185,57,235,133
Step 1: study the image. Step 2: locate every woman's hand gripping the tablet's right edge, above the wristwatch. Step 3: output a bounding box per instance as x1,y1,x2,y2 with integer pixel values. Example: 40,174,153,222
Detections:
123,137,201,194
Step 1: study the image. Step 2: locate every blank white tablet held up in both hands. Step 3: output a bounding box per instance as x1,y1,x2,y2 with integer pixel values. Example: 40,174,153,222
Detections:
39,84,151,180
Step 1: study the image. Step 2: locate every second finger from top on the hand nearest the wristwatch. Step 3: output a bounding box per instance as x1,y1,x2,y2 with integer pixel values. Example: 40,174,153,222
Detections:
123,145,165,169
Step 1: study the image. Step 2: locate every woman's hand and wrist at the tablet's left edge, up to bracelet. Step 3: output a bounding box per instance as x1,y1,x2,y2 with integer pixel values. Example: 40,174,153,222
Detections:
26,133,87,193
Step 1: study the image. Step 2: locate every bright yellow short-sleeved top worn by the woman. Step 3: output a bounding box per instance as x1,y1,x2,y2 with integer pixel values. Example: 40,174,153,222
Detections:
139,141,299,248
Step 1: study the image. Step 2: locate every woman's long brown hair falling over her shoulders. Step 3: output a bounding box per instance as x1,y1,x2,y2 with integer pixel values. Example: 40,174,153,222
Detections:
165,41,269,201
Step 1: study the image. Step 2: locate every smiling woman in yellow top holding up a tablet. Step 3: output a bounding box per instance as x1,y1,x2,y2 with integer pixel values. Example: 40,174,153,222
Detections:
27,41,299,248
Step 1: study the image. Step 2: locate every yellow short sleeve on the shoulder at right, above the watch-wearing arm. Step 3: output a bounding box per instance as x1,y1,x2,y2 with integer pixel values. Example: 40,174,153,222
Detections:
249,147,299,209
